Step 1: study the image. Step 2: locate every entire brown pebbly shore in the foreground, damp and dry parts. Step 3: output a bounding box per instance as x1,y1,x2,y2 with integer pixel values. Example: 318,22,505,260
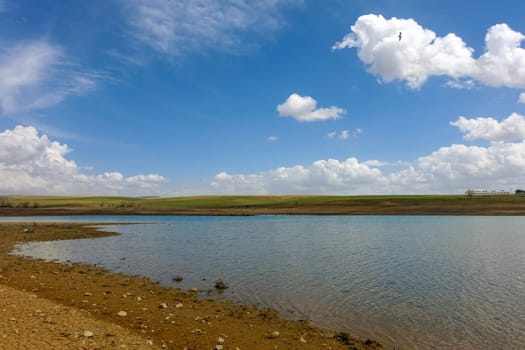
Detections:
0,223,382,350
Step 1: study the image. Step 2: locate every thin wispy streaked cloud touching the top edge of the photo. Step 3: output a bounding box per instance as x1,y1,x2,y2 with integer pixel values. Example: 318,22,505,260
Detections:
122,0,300,55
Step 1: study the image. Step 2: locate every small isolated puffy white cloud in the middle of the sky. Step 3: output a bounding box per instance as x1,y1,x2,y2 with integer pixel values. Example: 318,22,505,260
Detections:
277,93,345,122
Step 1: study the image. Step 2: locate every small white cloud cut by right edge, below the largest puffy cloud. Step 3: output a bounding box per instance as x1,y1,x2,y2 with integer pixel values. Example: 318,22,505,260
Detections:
450,113,525,141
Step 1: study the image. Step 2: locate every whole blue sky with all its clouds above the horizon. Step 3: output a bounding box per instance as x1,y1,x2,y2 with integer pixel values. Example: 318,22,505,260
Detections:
0,0,525,195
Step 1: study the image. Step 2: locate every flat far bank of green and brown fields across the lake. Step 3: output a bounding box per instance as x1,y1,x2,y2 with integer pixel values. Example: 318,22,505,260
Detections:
0,195,525,216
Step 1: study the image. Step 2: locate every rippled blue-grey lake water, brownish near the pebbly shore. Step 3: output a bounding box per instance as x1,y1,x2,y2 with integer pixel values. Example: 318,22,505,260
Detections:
4,216,525,349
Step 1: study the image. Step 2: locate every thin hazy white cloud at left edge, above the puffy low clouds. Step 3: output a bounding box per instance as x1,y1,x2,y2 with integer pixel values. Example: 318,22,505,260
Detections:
0,40,98,114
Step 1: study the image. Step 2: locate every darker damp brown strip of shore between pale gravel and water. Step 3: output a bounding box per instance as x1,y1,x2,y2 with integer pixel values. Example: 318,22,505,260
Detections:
0,222,382,350
